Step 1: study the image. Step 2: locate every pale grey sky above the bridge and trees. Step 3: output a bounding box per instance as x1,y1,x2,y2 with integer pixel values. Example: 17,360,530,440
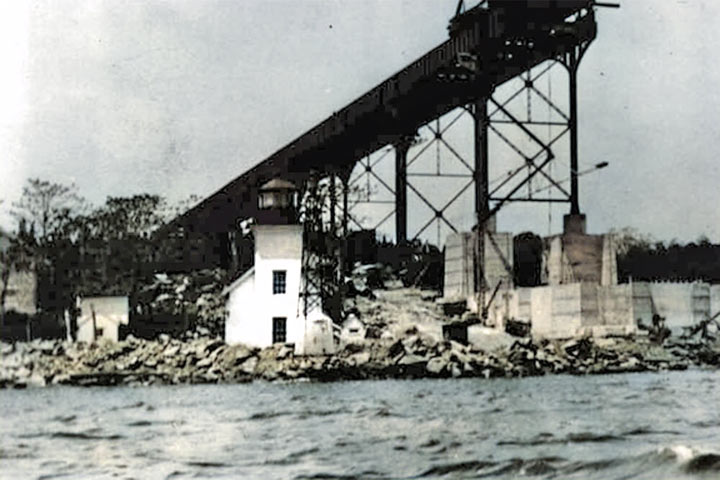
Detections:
0,0,720,242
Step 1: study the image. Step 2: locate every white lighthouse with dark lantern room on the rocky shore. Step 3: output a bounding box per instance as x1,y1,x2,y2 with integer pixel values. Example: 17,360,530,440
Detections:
225,179,334,354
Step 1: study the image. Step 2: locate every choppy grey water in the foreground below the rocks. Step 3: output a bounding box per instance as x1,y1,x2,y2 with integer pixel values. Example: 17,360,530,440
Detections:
0,371,720,480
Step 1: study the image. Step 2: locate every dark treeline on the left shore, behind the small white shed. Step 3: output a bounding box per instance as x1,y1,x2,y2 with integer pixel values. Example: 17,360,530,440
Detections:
0,178,242,335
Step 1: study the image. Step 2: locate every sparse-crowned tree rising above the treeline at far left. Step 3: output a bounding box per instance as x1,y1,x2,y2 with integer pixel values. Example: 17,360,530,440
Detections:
11,178,85,247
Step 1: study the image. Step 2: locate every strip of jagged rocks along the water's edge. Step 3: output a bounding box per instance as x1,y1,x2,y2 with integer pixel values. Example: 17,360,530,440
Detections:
0,329,720,388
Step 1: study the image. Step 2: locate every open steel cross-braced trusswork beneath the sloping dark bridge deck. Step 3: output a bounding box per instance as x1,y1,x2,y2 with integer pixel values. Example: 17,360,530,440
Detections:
342,42,590,244
